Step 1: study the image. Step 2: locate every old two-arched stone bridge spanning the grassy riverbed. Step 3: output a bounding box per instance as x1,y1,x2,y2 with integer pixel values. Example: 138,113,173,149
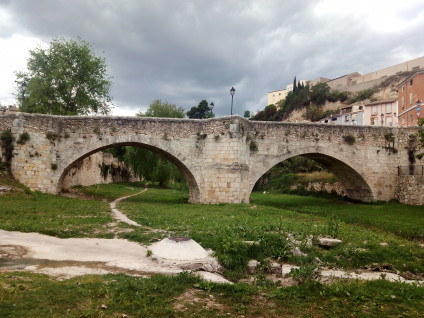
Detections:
0,113,417,204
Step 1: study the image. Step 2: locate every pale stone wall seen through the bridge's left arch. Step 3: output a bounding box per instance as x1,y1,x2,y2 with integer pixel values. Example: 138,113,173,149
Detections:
63,151,139,189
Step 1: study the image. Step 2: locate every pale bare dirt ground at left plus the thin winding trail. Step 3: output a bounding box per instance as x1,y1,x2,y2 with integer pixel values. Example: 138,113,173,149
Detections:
0,189,228,282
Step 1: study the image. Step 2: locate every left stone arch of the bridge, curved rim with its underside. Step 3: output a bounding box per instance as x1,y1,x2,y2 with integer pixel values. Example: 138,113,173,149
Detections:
56,141,200,203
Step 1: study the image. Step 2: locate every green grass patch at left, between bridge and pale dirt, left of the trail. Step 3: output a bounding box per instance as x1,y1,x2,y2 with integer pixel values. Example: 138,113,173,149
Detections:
0,192,113,238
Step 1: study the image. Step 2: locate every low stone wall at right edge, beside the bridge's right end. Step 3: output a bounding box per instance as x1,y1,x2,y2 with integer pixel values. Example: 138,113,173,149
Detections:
395,176,424,205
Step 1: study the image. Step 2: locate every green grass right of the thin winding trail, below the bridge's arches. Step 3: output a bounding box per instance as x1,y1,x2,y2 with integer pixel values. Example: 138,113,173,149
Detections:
119,189,424,280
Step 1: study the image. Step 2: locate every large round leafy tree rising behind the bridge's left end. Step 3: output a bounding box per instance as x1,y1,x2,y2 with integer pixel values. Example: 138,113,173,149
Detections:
15,38,113,115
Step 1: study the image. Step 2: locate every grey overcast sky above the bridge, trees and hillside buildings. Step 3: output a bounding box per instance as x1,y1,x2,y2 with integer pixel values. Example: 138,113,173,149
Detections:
0,0,424,116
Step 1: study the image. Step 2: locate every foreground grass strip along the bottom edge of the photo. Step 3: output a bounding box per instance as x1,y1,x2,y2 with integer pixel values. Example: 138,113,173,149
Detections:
0,273,424,317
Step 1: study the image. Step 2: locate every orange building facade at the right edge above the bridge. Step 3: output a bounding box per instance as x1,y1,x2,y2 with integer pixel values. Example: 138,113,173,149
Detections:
398,71,424,127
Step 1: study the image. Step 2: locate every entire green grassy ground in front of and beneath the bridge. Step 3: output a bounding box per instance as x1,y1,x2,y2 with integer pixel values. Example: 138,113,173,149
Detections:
0,178,424,317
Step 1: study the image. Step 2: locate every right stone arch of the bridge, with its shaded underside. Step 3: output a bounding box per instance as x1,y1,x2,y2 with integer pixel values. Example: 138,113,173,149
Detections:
249,147,375,202
